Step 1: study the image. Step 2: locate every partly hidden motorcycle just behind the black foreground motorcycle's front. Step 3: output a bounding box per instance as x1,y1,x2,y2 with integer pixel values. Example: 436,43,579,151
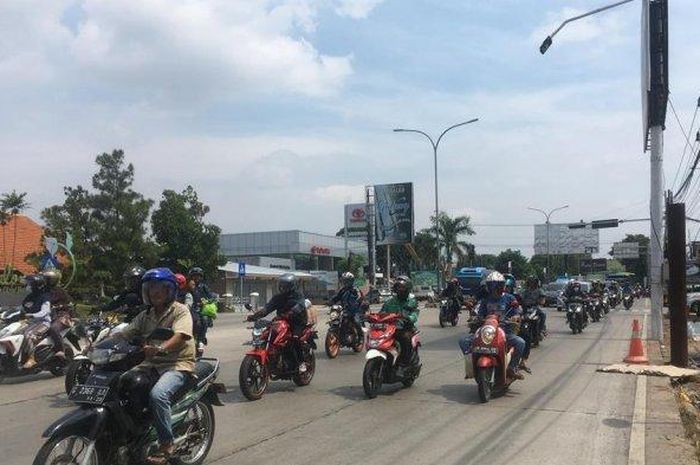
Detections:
64,313,129,394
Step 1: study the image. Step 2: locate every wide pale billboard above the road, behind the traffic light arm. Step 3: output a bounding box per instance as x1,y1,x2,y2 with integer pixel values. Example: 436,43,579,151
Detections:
534,223,600,255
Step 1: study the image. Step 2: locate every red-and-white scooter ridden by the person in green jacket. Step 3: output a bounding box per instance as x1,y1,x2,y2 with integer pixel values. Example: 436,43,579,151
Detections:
362,313,421,399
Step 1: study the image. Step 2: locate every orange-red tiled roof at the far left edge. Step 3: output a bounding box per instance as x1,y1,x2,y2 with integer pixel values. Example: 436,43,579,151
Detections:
0,215,44,275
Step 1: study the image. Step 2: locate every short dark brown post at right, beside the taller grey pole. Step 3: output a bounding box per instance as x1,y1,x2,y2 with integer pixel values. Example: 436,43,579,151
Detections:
666,198,688,368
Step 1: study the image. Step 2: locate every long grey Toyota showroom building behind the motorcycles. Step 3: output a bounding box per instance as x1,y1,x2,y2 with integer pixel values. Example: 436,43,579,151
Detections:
219,230,367,302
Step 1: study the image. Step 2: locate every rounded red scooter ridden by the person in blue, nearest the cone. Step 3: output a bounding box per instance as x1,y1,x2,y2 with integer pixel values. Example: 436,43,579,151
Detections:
465,315,517,402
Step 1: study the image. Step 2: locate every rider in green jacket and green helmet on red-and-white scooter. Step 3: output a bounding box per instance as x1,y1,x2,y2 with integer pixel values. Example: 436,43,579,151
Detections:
379,276,418,375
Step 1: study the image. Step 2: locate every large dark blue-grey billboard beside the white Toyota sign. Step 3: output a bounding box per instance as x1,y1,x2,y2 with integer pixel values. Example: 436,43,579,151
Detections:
374,182,413,245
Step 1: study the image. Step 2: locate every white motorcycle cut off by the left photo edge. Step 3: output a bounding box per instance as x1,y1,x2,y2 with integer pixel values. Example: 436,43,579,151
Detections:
0,312,86,382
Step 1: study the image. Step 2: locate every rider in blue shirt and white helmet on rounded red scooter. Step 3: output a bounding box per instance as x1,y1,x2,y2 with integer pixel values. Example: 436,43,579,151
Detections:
459,271,525,379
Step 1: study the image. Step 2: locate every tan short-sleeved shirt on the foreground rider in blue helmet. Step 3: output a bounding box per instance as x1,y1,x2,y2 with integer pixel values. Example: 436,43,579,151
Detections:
121,302,195,373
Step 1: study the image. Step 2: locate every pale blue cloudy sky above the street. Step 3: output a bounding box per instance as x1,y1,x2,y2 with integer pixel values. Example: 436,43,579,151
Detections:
0,0,700,255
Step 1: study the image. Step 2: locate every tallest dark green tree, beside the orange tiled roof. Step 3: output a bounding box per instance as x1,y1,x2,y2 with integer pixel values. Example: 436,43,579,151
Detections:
42,150,157,293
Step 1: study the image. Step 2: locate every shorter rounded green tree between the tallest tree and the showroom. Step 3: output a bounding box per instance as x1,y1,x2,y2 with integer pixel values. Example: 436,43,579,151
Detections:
151,186,225,277
